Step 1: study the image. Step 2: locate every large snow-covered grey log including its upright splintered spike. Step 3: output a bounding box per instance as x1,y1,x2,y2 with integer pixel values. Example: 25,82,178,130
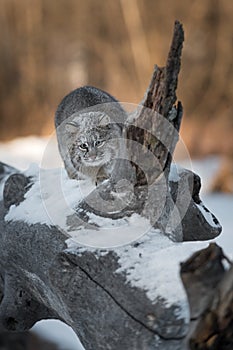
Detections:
0,22,225,350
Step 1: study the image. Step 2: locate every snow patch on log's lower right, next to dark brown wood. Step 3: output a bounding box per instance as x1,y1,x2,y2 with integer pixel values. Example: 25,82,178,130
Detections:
115,230,208,322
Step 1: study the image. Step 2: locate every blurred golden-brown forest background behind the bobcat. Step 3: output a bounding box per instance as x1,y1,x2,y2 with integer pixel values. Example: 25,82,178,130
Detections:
0,0,233,156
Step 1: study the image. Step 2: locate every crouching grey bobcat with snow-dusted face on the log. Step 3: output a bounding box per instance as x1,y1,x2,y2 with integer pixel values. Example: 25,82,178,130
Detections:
55,86,126,184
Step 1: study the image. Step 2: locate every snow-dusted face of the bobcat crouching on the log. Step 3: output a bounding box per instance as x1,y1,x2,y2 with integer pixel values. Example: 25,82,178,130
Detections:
66,113,121,170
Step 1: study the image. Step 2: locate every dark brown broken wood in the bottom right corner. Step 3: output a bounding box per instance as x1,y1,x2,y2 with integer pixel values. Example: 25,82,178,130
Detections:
181,243,233,350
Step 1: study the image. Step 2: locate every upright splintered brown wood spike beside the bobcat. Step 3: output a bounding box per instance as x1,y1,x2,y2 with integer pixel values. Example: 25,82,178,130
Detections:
127,22,184,185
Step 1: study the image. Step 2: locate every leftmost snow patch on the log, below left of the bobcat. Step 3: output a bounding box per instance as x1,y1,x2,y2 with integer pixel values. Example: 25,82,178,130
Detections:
5,164,93,230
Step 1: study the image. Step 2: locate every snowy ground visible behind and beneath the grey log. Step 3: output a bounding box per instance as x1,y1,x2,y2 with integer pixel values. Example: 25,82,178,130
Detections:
0,136,233,350
